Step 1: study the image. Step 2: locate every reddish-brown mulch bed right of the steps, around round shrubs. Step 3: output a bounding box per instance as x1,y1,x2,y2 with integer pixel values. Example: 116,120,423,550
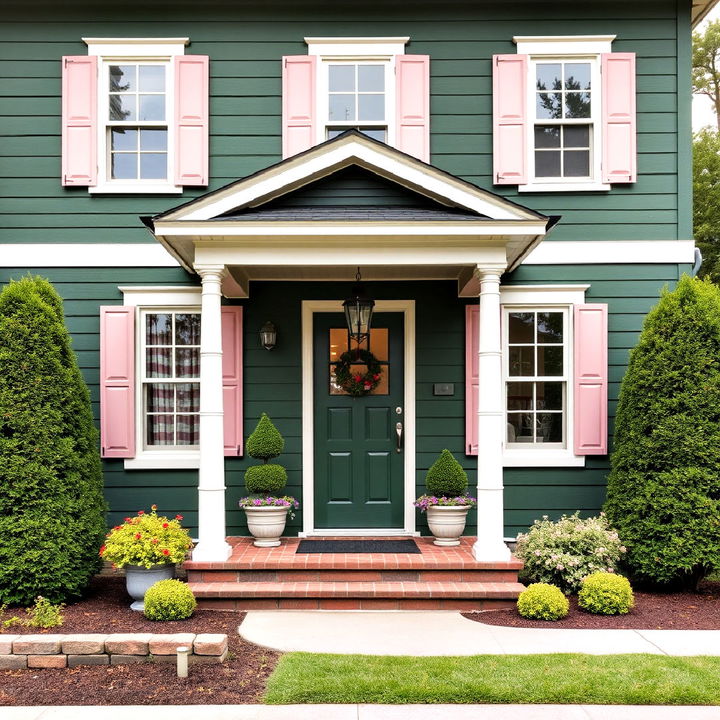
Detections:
463,582,720,630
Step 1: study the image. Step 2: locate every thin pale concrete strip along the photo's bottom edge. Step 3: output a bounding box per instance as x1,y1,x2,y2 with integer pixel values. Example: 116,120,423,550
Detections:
1,705,720,720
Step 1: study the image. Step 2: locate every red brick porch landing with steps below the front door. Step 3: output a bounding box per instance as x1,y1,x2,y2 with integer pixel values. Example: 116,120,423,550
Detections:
184,537,523,611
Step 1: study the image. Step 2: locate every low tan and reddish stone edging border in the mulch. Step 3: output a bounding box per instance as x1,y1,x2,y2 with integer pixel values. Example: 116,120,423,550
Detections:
0,633,228,670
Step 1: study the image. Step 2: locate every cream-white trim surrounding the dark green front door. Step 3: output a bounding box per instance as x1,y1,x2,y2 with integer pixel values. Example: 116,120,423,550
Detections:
302,300,416,536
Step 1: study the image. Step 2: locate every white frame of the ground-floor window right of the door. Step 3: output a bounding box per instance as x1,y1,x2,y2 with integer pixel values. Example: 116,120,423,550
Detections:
500,285,590,467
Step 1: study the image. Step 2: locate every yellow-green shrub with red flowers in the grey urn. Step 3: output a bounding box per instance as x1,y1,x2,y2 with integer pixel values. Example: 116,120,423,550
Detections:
100,505,192,568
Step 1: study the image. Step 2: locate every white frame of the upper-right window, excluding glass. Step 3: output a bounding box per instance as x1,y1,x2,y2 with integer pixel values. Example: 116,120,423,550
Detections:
513,35,615,192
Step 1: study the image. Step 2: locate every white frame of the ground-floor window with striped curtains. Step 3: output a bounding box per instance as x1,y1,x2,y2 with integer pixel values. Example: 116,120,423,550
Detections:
118,286,202,470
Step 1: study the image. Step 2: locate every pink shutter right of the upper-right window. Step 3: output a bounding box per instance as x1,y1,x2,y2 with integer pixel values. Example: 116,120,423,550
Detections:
602,53,637,183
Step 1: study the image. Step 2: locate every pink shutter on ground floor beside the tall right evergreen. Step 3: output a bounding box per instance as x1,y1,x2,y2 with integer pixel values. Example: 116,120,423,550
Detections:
574,304,608,455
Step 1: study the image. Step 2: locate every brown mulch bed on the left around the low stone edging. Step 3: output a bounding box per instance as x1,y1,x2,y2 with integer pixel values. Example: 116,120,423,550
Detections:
0,577,280,706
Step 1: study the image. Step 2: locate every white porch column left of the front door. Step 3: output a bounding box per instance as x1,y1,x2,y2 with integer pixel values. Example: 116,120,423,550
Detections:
193,265,232,562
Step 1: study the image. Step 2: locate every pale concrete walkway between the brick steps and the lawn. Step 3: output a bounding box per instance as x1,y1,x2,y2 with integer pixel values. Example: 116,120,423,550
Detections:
240,610,720,656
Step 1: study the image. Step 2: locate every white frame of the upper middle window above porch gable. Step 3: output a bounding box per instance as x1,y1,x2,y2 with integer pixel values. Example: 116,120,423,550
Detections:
305,37,410,147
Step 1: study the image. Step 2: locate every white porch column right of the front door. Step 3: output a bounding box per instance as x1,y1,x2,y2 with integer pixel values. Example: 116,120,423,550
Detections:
473,265,510,562
